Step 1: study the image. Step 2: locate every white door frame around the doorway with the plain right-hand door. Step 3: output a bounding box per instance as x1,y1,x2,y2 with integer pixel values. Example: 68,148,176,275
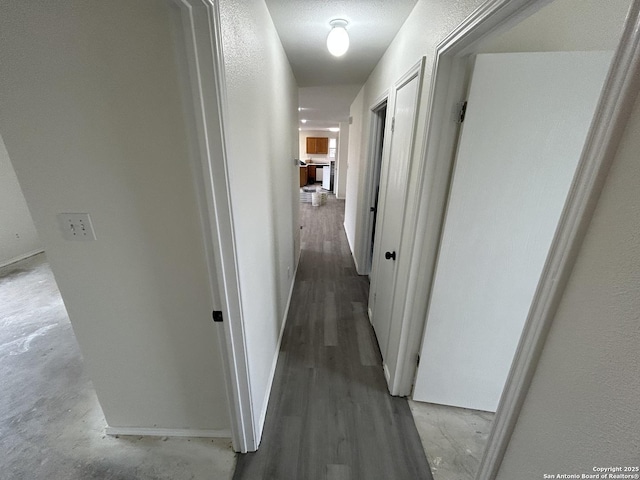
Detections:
399,0,640,480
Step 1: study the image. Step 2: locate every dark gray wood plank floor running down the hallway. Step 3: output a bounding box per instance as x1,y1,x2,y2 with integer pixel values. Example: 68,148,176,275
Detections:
233,196,432,480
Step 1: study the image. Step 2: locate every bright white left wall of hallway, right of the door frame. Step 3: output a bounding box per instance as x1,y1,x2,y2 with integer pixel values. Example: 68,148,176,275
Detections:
220,0,299,440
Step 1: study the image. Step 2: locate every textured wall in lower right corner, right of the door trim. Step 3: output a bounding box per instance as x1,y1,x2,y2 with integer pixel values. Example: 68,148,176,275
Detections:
497,89,640,480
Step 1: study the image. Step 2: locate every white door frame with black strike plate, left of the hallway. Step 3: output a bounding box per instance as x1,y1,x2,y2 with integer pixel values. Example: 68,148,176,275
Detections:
169,0,259,453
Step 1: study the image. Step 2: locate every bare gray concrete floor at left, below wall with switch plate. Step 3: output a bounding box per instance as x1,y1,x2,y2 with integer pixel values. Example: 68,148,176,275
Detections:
0,254,235,480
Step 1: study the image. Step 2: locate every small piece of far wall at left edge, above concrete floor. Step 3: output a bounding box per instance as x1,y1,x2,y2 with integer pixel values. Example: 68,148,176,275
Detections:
0,137,43,266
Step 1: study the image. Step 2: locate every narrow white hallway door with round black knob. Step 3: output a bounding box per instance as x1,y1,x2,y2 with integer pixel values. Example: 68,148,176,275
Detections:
369,66,420,376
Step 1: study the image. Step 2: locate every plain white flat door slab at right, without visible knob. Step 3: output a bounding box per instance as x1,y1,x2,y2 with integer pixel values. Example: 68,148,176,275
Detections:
413,52,611,411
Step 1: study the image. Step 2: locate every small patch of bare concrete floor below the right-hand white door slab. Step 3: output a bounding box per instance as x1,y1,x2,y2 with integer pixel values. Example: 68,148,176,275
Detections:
409,401,494,480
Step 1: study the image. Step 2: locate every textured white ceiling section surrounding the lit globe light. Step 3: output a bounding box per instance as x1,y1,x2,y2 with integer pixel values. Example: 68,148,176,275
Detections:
266,0,417,87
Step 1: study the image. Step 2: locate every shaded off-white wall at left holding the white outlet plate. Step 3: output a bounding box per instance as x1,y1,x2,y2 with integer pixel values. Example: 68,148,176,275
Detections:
0,0,230,434
